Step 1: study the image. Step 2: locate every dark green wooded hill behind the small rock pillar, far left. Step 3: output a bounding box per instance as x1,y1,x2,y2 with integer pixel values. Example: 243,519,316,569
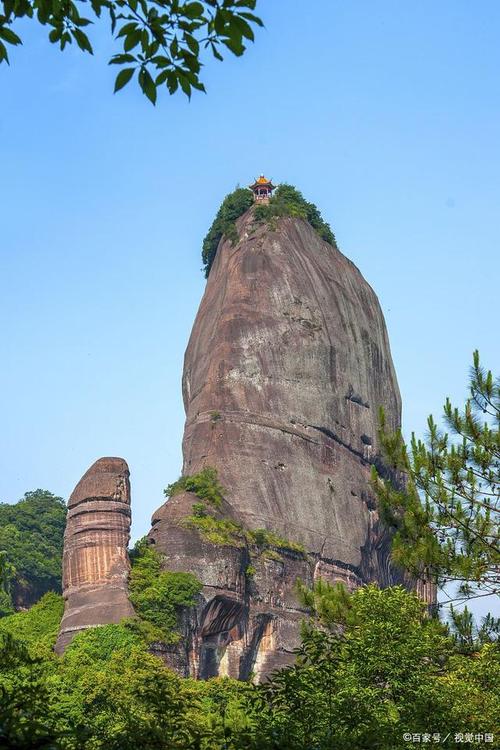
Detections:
0,490,67,616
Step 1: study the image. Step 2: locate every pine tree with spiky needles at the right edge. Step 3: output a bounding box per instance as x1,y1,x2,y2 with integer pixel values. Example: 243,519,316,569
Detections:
373,351,500,599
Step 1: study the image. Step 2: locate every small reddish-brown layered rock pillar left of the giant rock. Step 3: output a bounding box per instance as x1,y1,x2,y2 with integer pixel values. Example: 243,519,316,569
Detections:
56,458,134,653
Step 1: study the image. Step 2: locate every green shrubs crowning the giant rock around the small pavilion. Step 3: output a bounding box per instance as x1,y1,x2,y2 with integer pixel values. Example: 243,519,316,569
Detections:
201,183,337,278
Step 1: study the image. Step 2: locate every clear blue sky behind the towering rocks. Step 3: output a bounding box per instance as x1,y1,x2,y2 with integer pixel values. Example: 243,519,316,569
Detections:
0,0,500,612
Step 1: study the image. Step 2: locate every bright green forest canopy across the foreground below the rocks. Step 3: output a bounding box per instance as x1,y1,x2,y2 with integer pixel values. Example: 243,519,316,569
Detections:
0,584,500,750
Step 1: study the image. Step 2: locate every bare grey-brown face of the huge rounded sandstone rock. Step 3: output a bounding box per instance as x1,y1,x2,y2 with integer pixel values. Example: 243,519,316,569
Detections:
150,210,401,678
